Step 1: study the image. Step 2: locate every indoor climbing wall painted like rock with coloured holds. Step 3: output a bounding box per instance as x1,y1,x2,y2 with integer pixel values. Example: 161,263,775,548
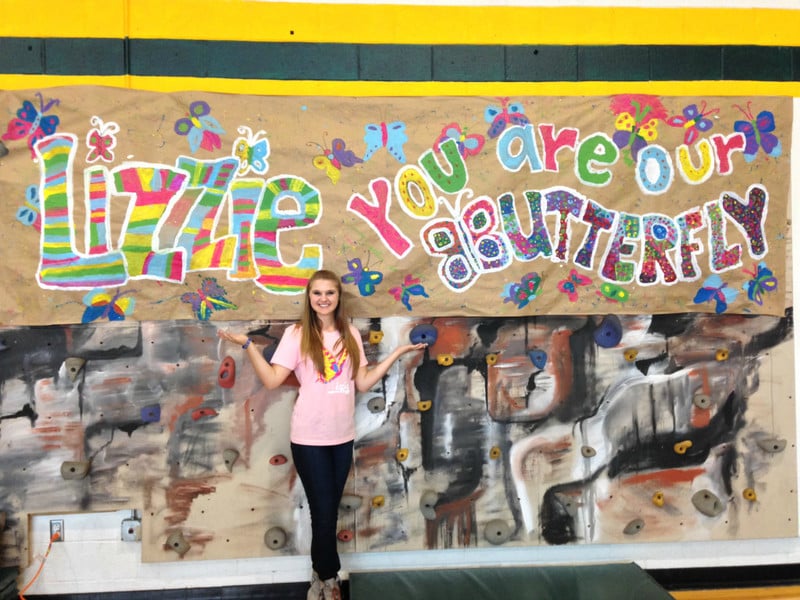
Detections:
0,312,797,561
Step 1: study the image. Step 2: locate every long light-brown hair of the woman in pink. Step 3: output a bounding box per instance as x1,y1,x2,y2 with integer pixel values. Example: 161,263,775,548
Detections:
298,269,361,379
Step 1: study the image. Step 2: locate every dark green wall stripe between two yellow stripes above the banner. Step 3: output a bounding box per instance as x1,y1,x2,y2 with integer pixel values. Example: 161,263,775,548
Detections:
0,37,800,82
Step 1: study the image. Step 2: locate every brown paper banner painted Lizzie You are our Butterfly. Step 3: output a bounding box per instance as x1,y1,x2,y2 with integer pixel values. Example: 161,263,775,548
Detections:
0,87,792,325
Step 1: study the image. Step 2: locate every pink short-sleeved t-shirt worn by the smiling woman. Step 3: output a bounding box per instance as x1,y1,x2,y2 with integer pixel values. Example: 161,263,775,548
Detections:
272,325,367,446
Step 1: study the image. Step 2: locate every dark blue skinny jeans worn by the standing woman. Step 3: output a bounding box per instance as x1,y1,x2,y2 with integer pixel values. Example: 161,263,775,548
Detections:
292,441,353,581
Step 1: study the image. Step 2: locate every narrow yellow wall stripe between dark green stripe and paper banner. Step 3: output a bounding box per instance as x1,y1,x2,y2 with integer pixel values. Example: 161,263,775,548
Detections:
0,74,800,97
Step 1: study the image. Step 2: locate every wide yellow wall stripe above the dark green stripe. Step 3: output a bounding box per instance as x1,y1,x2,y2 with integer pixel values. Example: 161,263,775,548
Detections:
0,0,800,46
